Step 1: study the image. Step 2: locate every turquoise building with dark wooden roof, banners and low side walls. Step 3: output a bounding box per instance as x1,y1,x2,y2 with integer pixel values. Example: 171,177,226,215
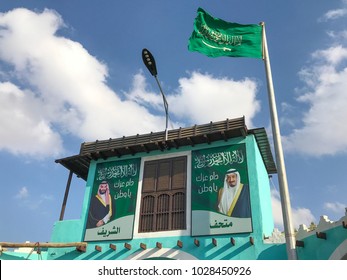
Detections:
0,118,347,260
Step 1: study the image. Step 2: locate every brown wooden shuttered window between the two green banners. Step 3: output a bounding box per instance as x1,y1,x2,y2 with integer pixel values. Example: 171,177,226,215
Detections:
139,157,187,232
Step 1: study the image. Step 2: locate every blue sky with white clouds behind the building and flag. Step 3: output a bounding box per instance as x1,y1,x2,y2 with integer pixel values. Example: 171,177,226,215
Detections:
0,0,347,242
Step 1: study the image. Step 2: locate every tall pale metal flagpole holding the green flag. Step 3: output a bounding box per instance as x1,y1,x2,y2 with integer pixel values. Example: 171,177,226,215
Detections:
261,22,297,260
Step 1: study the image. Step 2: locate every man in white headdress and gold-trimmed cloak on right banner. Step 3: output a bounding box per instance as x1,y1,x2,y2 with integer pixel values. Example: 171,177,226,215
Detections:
218,169,251,218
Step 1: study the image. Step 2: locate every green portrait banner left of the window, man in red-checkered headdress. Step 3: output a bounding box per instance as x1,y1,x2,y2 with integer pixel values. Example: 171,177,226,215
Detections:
84,159,140,241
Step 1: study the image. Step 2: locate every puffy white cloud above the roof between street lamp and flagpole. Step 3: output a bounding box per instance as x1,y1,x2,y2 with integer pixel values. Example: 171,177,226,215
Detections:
168,72,260,127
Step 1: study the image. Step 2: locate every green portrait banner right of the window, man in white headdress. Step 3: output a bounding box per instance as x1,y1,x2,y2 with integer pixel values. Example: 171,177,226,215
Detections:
192,144,252,236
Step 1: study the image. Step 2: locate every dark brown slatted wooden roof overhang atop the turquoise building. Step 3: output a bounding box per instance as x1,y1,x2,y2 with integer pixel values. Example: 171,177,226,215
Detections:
56,117,277,180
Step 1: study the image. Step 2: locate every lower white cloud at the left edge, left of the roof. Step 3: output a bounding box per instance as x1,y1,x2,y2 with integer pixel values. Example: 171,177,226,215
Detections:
0,82,63,156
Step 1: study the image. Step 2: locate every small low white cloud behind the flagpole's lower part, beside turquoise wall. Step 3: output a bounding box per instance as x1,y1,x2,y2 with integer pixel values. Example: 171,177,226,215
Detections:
271,189,315,229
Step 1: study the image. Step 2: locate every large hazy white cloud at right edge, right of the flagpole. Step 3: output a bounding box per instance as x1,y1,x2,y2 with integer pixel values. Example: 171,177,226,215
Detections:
283,45,347,156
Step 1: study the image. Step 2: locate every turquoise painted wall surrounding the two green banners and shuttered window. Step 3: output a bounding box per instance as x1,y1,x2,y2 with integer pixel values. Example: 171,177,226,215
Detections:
48,119,286,260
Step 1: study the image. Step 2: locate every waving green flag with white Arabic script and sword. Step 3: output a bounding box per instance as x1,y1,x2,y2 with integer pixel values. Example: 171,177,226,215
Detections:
188,8,262,58
